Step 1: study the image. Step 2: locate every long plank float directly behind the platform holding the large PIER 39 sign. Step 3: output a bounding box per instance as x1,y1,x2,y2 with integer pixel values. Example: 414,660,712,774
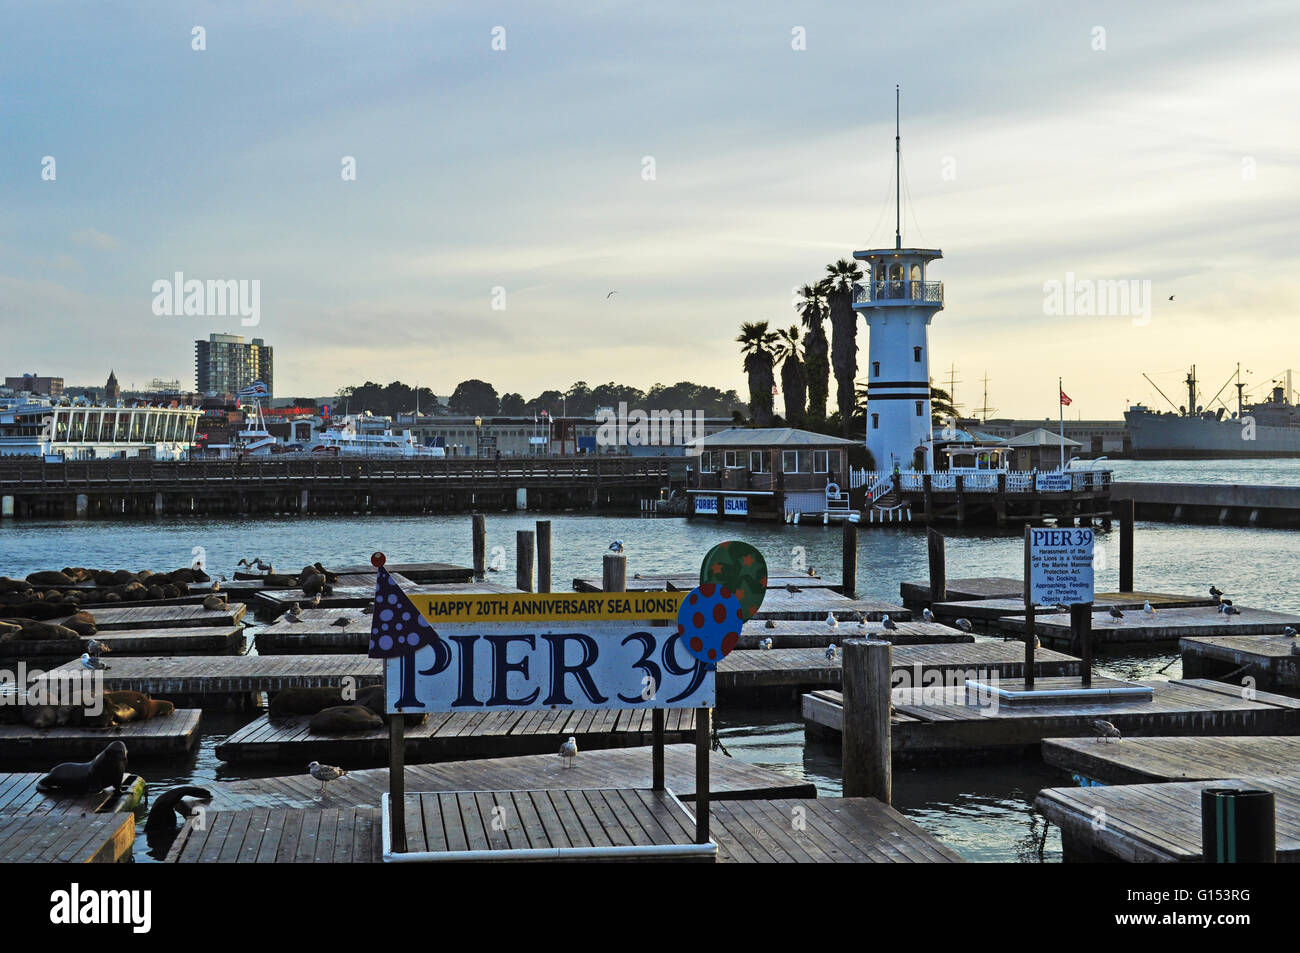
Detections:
219,745,816,807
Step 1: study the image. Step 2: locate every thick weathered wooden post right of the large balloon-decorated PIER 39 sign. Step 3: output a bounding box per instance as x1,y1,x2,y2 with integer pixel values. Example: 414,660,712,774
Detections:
840,638,893,803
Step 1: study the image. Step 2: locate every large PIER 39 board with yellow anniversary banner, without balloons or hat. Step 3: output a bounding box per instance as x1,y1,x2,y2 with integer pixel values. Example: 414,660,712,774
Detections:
385,593,715,712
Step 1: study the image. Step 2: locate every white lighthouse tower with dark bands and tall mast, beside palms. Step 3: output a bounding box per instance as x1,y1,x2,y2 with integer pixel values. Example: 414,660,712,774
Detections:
853,91,944,471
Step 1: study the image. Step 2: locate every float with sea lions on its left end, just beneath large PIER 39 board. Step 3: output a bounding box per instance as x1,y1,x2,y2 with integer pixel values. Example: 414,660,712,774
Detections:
216,709,696,767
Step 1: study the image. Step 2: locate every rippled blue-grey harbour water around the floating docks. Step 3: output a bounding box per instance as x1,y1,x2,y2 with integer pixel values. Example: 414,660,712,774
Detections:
0,460,1300,862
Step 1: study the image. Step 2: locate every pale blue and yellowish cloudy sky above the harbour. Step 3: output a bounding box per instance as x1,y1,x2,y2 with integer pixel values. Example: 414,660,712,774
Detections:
0,0,1300,419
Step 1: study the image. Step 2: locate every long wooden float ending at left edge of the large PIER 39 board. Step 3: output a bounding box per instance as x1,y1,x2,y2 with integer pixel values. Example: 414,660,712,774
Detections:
33,655,384,701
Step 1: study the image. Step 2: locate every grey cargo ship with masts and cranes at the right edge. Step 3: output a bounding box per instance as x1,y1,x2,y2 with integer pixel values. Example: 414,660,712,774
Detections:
1125,365,1300,459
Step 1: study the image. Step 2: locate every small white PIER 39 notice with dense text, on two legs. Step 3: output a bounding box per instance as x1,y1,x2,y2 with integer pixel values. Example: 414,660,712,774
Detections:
1024,527,1096,688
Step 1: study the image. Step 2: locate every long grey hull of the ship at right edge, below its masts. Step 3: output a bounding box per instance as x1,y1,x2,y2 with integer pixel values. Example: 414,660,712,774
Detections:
1125,411,1300,459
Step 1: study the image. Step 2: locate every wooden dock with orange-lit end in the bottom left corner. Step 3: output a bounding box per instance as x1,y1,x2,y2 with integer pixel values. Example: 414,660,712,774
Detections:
0,811,135,863
